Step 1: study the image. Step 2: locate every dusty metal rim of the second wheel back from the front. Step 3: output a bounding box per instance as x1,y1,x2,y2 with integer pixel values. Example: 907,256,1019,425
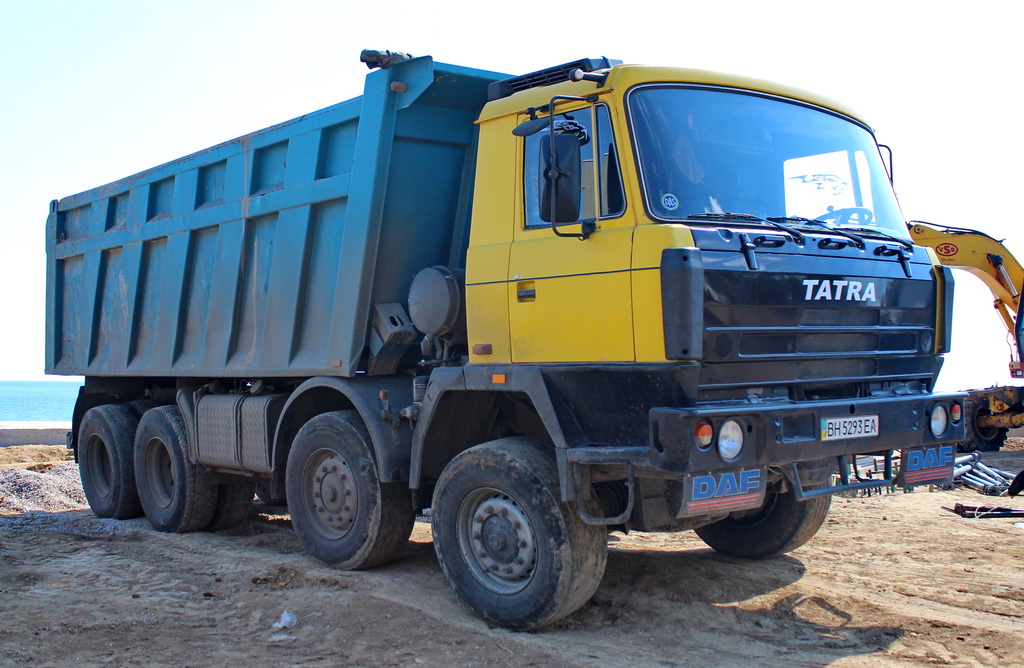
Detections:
302,449,359,539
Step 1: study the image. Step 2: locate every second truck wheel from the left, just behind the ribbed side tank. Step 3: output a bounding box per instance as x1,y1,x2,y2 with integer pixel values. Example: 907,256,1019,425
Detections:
135,406,217,534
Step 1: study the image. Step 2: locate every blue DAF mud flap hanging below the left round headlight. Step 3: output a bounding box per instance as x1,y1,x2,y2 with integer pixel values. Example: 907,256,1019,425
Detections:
676,468,768,517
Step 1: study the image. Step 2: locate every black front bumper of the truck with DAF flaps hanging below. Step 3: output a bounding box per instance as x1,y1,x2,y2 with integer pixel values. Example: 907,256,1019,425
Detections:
559,393,966,524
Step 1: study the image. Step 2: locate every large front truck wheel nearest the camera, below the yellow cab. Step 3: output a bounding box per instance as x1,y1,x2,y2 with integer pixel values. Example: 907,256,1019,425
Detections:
431,437,608,629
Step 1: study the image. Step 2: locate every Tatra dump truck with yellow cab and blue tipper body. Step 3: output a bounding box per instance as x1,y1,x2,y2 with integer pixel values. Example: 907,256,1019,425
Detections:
46,52,964,628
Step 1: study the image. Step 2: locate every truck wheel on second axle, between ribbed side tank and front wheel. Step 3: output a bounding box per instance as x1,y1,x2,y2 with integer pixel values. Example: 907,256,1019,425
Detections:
285,411,416,570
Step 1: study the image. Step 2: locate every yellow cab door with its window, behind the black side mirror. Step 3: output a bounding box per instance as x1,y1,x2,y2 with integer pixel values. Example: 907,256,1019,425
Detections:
507,105,635,363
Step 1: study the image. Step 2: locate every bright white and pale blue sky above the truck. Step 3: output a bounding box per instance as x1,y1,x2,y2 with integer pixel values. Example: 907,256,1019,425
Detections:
0,0,1024,389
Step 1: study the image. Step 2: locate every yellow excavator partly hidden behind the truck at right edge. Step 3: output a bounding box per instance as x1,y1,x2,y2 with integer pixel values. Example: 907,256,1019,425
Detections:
909,220,1024,451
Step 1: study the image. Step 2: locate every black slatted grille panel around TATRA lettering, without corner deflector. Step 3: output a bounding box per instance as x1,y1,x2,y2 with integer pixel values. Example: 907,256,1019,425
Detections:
699,270,935,389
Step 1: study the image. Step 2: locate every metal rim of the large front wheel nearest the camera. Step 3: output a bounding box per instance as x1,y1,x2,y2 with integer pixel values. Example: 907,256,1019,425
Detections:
458,488,537,594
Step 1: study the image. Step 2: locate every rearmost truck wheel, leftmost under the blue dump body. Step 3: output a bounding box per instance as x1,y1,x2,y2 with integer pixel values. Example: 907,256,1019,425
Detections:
78,404,142,519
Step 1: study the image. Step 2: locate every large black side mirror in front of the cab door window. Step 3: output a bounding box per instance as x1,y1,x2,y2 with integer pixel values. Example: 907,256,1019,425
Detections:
539,134,583,223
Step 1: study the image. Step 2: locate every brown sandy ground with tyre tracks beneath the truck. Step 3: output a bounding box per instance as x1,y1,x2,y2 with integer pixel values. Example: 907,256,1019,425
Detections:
0,443,1024,666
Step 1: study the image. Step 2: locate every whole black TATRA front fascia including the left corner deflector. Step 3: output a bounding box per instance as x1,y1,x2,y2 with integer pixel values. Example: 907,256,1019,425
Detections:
662,241,938,401
